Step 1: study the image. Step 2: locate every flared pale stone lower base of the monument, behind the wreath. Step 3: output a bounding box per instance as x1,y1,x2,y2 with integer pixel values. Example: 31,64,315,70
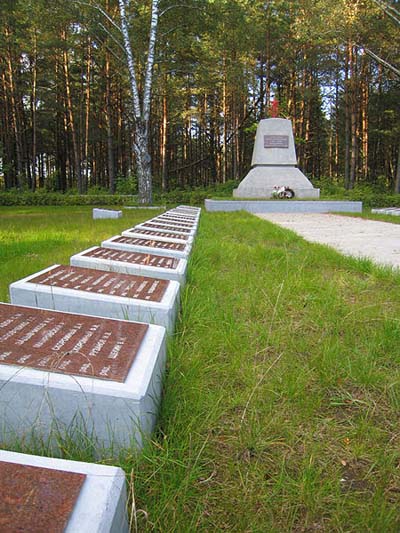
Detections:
233,165,319,199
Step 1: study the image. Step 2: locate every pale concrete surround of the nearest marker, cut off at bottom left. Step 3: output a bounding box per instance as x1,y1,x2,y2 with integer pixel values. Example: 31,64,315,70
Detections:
0,450,129,533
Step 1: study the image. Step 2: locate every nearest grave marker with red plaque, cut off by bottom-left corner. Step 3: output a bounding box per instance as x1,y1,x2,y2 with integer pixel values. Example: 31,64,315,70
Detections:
0,450,129,533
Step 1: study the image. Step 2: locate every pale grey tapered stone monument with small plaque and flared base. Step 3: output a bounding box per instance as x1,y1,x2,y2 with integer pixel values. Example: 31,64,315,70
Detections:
233,118,319,199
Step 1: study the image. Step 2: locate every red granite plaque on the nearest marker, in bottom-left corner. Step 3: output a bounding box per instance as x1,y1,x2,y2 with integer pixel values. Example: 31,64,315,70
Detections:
0,461,86,533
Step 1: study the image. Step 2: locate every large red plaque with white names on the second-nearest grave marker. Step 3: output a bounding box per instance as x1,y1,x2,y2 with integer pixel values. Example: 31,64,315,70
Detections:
0,304,149,383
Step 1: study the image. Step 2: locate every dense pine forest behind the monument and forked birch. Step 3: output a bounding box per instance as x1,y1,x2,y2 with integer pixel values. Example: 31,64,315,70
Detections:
0,0,400,200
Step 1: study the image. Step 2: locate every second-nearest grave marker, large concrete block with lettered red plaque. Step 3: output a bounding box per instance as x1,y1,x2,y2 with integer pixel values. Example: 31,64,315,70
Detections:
0,304,165,450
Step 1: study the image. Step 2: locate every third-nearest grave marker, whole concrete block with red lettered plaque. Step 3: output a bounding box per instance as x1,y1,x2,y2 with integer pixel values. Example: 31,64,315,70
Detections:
10,265,180,332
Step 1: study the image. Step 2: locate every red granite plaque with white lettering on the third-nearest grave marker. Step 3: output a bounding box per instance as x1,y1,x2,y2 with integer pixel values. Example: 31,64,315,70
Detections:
29,265,168,302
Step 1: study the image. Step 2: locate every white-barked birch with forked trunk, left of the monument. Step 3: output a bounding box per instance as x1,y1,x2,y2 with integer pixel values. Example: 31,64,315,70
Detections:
118,0,159,204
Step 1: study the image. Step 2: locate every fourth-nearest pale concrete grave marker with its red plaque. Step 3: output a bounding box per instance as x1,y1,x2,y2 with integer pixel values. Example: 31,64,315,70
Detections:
70,246,187,283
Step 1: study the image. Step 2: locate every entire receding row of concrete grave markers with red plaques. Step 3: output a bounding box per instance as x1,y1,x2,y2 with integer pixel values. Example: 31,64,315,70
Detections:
0,206,201,533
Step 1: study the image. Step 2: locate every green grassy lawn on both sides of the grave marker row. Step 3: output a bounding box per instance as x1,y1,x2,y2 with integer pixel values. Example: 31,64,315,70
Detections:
0,207,400,533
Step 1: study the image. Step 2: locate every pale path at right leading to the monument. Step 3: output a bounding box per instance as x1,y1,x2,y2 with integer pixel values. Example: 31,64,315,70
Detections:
257,213,400,267
